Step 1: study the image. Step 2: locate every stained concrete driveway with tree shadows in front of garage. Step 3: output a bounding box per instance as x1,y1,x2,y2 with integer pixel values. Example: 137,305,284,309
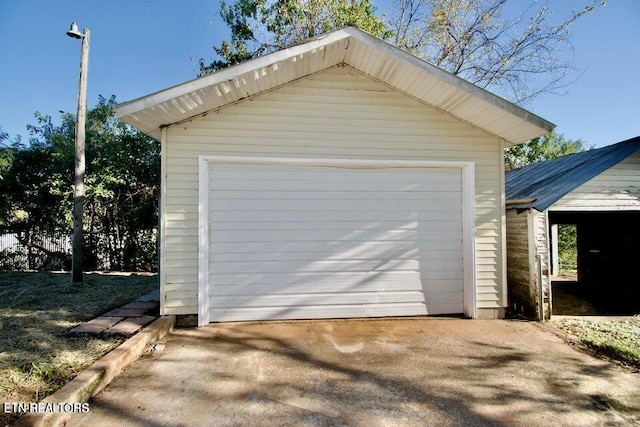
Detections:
67,318,640,427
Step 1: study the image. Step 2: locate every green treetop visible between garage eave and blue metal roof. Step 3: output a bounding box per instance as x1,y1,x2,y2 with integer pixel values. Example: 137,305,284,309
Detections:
504,132,593,170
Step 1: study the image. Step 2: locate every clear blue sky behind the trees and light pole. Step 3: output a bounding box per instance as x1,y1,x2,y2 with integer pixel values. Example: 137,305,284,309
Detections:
0,0,640,147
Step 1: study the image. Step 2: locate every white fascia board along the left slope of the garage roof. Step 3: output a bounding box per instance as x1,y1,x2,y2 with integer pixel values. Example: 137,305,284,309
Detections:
116,29,350,117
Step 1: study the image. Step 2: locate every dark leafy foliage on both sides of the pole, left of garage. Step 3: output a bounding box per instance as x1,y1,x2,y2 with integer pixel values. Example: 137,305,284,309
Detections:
0,96,160,270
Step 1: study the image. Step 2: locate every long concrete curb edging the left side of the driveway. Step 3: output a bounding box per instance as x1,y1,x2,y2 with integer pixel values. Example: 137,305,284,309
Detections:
14,316,176,427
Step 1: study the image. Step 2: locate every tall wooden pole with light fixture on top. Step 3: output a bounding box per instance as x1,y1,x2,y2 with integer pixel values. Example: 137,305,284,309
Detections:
67,22,89,283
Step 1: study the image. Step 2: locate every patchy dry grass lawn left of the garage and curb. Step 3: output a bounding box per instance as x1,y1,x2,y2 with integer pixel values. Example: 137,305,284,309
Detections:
0,273,157,425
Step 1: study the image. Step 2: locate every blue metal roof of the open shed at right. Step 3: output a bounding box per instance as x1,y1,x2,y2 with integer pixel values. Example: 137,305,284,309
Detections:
505,136,640,211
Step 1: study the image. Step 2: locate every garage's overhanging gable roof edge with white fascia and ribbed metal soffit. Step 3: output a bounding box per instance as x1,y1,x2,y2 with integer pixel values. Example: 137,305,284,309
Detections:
116,27,554,145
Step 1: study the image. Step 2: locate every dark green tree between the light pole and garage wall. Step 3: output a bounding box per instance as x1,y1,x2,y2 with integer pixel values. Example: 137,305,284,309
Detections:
85,97,160,271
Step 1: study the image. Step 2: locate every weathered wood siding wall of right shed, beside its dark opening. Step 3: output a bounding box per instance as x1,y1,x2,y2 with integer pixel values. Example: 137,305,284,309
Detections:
507,209,550,317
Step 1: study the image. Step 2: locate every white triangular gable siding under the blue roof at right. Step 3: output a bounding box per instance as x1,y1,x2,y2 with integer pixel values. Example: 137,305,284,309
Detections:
549,151,640,211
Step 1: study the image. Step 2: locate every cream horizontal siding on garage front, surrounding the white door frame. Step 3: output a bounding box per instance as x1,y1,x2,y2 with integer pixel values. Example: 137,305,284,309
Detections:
162,66,505,314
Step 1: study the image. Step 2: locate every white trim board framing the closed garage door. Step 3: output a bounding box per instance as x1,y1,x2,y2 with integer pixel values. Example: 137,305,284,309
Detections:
198,156,477,326
